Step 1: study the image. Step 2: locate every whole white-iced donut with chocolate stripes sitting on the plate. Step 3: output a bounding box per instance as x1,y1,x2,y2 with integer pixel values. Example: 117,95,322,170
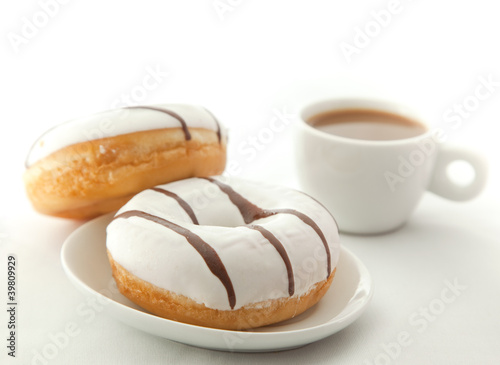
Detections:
106,176,340,330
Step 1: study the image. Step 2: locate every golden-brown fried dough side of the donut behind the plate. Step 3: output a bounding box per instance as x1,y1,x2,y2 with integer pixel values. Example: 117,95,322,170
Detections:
23,128,226,219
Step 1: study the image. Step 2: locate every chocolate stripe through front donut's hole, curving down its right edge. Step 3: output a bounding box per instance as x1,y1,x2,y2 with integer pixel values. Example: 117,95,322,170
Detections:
203,177,332,278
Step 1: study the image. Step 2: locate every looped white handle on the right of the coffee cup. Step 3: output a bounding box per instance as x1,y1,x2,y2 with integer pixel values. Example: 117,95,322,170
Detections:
428,145,488,201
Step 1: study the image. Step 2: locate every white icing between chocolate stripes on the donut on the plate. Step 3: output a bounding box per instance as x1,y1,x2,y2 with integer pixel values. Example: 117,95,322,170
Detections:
107,177,340,310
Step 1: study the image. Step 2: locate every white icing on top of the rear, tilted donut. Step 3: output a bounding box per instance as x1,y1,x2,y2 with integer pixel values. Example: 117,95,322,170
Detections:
26,104,226,166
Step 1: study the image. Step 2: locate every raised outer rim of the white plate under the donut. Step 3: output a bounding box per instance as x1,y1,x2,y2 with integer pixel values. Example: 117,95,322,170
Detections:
60,212,374,352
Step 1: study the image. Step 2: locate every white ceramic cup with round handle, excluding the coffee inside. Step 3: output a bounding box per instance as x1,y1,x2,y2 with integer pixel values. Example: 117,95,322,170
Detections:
295,98,488,234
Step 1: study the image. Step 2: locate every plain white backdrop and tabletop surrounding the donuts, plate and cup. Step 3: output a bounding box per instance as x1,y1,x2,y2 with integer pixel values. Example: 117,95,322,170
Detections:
0,0,500,364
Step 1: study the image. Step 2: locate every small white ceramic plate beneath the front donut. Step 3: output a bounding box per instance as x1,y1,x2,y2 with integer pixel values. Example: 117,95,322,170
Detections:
61,214,373,352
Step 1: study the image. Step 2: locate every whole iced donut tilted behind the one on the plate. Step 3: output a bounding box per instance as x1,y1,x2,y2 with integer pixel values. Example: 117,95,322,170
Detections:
24,104,227,218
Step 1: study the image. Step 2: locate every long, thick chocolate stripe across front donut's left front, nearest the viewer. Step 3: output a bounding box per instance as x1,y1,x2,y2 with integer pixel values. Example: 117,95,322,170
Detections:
114,210,236,309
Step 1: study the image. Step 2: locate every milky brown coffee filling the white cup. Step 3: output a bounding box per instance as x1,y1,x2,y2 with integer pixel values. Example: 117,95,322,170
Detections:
307,109,427,141
